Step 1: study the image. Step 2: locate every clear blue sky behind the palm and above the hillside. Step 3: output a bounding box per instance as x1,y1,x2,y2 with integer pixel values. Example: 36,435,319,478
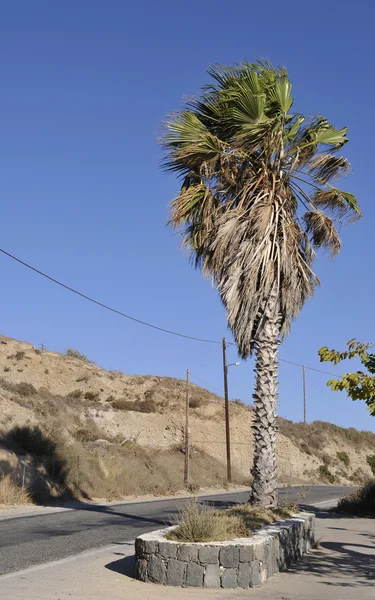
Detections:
0,0,375,431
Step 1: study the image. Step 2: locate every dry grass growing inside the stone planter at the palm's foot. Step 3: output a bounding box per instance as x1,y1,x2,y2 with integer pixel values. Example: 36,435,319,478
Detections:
167,500,291,542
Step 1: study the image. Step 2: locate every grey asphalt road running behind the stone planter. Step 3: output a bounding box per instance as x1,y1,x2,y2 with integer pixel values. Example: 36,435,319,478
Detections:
0,486,348,575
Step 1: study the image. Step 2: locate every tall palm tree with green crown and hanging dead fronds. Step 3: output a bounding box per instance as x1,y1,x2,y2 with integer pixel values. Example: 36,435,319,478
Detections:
162,61,360,507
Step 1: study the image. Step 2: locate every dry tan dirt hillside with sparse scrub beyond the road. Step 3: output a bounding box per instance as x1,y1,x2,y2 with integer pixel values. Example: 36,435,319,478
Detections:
0,336,375,498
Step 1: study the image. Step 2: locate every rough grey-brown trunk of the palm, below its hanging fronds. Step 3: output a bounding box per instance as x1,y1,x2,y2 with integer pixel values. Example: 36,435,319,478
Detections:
250,292,280,508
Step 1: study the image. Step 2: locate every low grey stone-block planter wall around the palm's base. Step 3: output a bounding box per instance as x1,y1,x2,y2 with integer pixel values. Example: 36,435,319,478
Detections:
135,513,315,588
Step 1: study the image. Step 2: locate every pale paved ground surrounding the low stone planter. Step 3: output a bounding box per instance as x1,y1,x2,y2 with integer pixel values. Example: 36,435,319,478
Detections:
0,506,375,600
